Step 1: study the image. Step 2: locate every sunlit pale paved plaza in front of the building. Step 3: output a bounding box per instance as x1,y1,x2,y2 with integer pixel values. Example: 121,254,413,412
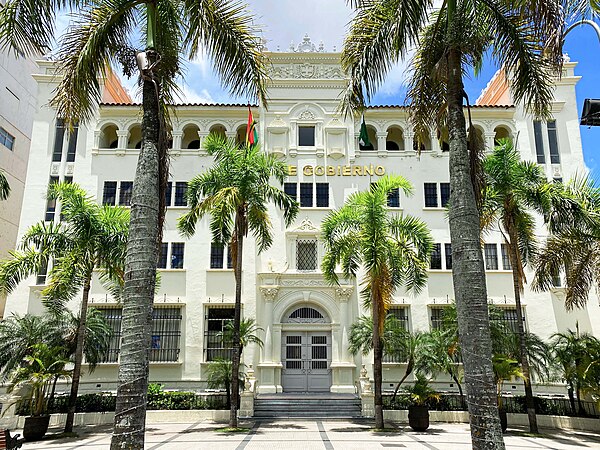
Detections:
17,419,600,450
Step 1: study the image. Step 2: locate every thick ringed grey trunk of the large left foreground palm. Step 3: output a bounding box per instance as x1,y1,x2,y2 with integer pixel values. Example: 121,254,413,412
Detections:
111,60,160,450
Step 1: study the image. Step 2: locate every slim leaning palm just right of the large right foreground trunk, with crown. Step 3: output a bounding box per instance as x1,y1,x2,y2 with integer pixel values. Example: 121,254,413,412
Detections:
481,139,552,433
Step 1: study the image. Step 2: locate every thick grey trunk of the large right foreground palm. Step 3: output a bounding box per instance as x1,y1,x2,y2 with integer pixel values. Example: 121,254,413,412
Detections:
447,44,504,450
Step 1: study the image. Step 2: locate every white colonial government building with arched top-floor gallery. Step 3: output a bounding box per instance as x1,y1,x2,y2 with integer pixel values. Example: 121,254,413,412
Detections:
5,34,600,393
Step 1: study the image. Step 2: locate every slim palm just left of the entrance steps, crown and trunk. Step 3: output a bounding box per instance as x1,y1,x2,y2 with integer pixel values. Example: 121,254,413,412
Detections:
177,134,298,428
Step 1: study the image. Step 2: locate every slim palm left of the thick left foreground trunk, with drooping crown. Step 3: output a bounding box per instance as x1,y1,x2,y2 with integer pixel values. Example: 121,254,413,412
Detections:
0,183,129,432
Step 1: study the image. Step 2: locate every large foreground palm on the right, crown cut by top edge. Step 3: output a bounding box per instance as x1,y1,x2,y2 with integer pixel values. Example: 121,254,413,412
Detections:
342,0,563,449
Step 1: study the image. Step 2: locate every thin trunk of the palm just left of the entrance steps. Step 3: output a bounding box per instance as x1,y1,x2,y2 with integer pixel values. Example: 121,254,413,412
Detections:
229,207,245,428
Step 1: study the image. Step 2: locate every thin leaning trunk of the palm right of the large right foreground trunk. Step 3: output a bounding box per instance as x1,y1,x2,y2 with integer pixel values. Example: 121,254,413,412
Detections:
507,230,538,434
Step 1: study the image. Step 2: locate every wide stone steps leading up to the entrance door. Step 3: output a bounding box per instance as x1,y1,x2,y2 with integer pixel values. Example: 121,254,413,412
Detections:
254,393,362,419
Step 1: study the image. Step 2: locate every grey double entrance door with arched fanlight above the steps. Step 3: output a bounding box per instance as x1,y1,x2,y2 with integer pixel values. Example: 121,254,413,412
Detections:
281,306,331,392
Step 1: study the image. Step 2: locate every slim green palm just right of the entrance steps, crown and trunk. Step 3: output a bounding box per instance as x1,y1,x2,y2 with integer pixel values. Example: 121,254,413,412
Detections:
321,176,433,428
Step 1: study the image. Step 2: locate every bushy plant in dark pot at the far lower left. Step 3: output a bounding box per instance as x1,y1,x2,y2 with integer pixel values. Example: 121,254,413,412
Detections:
9,344,69,441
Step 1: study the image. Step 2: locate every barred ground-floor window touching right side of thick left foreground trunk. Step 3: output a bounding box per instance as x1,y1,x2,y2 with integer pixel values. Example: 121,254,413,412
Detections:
150,307,181,362
